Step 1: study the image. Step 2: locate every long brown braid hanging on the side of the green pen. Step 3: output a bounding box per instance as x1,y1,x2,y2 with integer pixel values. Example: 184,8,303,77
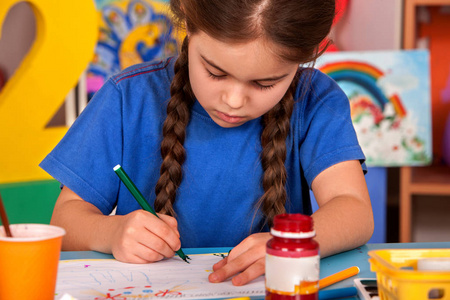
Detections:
155,37,194,216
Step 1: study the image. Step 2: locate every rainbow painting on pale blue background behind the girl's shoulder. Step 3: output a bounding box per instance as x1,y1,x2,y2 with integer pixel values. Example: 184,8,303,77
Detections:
316,51,432,166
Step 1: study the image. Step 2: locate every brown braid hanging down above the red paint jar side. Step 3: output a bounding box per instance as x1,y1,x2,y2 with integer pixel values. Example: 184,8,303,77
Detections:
257,74,298,226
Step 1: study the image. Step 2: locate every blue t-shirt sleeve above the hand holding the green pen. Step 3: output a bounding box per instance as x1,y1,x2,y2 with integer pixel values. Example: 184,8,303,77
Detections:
40,80,122,214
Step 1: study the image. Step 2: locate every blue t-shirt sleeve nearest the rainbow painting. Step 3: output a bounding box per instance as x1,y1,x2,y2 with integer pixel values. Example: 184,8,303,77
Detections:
299,70,367,187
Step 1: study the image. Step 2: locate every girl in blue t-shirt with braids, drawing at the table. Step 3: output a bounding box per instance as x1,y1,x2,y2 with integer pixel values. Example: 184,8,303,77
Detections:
41,0,373,285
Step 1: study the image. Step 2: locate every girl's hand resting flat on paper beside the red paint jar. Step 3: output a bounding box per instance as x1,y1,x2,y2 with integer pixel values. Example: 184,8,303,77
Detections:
208,232,271,285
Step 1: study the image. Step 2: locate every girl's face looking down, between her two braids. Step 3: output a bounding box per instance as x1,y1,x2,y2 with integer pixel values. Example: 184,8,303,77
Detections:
189,31,298,127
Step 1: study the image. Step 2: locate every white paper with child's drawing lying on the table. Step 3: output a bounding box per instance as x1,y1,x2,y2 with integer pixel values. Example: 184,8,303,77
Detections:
56,254,264,300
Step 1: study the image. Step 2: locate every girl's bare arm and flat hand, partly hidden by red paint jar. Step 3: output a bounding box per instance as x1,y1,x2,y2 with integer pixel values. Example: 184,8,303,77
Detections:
209,160,374,285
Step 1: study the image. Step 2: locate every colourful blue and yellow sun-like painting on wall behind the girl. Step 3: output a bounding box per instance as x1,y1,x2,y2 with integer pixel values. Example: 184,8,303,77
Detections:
87,0,177,96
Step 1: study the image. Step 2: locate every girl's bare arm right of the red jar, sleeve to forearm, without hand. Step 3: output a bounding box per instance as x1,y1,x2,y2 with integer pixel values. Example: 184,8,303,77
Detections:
311,161,374,257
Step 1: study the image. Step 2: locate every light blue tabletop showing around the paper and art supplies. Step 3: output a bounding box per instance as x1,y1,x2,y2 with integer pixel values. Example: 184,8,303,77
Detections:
61,242,450,299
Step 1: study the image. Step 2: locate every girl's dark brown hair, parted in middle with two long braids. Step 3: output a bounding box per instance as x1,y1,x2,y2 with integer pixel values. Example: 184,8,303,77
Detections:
155,0,335,225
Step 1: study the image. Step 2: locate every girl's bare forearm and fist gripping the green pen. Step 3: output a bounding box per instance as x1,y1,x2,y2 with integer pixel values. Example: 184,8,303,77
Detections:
50,186,181,263
